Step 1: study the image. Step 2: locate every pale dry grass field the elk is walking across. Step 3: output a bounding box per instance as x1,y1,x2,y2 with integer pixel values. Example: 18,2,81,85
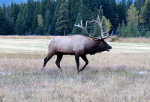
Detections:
0,36,150,102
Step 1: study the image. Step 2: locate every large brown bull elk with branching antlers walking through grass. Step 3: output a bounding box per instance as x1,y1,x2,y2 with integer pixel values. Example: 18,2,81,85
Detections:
43,18,112,73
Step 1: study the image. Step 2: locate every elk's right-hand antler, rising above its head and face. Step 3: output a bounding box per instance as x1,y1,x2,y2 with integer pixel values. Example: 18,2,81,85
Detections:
90,16,110,39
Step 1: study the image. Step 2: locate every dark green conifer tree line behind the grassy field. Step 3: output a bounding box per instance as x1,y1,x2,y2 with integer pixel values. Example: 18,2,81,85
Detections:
0,0,150,37
